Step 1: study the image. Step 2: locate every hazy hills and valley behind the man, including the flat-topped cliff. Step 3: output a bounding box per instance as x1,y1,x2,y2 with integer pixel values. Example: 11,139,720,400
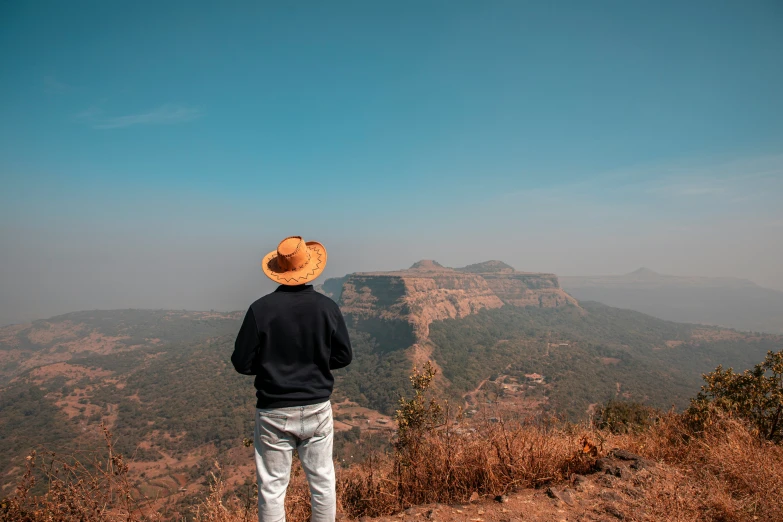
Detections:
0,261,783,503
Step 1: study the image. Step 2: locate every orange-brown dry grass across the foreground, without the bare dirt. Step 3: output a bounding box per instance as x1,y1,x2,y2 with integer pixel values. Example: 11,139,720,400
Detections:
0,414,783,522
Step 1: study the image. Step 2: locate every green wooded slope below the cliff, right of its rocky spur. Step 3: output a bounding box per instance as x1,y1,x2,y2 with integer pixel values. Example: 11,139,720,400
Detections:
430,302,781,420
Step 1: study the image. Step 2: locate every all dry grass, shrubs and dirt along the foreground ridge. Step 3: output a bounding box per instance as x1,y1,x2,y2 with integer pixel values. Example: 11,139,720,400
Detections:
0,351,783,522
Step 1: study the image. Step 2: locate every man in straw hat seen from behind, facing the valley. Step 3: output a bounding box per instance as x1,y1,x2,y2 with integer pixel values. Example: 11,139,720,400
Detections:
231,236,353,522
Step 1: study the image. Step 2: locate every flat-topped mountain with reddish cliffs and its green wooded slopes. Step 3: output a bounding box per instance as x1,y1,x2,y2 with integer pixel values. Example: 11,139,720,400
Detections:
320,261,780,418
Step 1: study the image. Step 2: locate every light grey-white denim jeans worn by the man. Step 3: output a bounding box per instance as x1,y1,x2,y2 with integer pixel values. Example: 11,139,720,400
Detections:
255,401,337,522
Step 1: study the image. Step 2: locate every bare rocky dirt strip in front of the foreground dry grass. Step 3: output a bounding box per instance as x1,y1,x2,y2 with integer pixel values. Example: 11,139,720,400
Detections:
360,449,666,522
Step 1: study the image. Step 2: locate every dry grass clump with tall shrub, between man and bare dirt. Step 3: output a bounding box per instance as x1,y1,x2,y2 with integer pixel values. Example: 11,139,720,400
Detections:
339,363,594,517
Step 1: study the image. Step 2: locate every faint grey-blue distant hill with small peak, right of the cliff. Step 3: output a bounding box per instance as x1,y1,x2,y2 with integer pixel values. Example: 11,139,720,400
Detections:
560,268,783,334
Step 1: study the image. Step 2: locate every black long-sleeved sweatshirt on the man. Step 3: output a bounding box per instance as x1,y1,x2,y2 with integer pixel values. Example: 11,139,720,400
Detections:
231,285,353,408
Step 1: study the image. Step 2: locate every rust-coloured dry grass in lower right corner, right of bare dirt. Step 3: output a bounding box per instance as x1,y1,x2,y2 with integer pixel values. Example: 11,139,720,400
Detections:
611,413,783,521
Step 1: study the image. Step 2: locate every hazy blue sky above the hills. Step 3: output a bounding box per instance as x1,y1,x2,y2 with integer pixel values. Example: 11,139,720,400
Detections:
0,1,783,324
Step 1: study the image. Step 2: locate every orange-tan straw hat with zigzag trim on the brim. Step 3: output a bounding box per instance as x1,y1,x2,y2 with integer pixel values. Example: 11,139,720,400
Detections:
261,236,326,286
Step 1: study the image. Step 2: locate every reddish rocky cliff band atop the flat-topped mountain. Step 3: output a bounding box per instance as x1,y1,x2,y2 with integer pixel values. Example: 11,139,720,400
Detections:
321,260,578,342
